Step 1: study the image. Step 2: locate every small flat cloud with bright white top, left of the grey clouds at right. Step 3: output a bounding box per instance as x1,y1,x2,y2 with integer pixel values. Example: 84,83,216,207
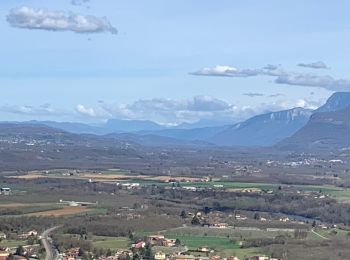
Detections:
190,65,261,78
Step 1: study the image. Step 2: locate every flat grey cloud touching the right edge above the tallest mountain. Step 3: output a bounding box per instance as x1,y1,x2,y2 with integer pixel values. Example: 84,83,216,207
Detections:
275,73,350,91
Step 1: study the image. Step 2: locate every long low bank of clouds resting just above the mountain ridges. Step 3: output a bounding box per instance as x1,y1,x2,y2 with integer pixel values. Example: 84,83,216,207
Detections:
77,96,322,125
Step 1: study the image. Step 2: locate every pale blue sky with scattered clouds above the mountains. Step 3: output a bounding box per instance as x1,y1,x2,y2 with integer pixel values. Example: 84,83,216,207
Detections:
0,0,350,125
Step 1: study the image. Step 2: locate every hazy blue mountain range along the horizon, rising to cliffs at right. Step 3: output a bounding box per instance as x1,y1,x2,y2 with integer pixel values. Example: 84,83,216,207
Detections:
0,92,350,150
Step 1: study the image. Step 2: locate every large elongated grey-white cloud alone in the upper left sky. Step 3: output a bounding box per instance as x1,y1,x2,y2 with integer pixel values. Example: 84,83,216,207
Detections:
7,6,117,34
